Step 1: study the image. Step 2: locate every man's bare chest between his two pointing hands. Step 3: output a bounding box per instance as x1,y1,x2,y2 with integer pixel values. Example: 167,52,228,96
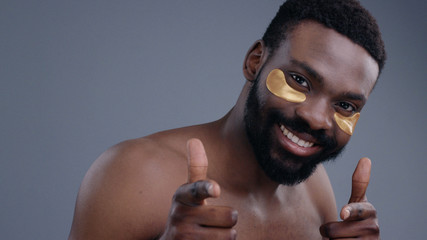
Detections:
207,188,323,240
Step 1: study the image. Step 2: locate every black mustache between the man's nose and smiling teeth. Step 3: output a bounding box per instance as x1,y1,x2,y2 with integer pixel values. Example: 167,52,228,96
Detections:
270,110,337,148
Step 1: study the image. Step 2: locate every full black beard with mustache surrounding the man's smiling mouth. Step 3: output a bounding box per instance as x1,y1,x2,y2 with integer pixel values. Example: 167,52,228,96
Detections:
244,79,344,186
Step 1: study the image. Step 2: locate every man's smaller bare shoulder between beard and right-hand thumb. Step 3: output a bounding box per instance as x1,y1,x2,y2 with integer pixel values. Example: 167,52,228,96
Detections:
306,164,337,222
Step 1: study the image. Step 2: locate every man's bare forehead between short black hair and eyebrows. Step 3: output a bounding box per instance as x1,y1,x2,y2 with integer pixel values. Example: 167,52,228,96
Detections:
271,21,378,97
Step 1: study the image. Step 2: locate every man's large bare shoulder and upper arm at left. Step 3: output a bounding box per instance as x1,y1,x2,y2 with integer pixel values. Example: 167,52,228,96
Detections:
70,135,187,239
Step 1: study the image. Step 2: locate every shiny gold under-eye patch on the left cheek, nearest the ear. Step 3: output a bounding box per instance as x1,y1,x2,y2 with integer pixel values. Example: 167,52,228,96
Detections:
266,69,306,103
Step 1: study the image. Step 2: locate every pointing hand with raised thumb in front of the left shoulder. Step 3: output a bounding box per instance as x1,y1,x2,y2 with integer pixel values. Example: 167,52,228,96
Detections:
160,139,237,240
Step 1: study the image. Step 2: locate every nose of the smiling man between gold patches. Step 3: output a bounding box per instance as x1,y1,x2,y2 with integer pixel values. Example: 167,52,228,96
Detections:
295,99,333,131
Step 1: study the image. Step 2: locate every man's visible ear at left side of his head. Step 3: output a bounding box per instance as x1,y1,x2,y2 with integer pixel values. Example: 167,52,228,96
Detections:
243,40,267,82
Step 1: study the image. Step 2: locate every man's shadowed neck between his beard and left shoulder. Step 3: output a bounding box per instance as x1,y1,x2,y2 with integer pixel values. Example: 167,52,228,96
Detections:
209,84,279,196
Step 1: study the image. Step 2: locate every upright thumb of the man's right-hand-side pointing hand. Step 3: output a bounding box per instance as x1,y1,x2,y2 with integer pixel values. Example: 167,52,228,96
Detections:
348,158,371,203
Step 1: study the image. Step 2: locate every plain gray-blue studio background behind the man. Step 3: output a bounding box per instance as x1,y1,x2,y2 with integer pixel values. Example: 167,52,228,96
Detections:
0,0,427,239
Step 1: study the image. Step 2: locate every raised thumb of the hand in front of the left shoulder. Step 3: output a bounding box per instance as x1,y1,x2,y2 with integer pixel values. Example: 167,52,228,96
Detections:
187,138,208,183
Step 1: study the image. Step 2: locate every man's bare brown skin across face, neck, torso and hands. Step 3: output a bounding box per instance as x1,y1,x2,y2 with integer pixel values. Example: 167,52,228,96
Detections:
69,22,379,240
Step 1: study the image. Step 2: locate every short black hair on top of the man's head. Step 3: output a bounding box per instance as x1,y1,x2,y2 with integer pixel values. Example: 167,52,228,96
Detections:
262,0,386,72
